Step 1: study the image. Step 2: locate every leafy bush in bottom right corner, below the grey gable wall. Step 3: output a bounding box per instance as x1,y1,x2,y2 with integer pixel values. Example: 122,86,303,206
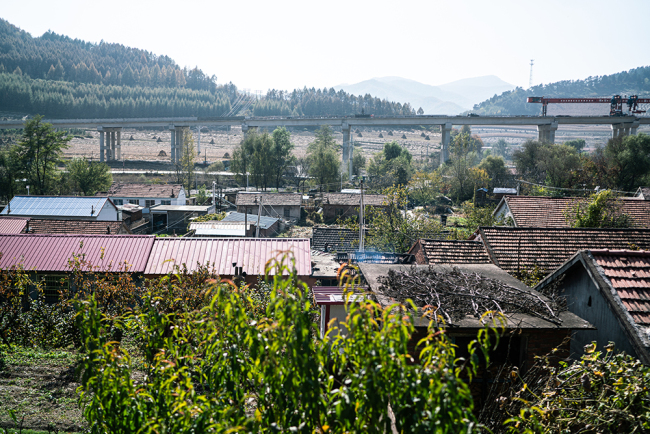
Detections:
499,343,650,433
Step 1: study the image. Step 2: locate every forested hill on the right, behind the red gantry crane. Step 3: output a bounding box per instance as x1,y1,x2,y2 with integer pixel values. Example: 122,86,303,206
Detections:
472,66,650,116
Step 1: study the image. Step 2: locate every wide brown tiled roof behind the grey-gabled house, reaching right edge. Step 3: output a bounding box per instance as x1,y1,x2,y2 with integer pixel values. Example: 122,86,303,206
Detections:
478,227,650,273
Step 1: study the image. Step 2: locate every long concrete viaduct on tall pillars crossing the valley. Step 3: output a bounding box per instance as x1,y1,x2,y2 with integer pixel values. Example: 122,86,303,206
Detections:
0,115,650,171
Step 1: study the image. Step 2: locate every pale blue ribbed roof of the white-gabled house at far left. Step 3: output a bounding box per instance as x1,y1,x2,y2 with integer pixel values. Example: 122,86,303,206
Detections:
0,196,115,218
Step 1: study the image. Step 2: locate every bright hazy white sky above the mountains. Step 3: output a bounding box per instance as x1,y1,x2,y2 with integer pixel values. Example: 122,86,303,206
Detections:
0,0,650,92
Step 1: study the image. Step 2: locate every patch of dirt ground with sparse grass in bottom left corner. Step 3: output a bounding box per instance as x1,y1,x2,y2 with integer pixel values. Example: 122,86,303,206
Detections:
0,348,85,432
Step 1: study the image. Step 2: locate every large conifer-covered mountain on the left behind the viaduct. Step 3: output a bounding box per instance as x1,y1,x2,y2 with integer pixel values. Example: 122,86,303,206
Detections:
0,19,414,118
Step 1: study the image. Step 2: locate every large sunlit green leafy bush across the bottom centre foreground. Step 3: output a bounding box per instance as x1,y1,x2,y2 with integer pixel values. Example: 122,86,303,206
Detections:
77,258,496,433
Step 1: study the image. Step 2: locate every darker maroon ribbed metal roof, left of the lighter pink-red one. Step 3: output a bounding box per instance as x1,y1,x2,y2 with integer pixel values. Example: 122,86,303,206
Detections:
0,234,154,273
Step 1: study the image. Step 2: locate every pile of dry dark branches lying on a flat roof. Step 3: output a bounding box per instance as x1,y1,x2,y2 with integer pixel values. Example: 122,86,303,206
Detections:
379,267,566,324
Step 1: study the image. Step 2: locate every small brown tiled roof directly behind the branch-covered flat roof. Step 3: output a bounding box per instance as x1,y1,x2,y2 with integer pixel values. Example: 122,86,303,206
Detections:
418,239,490,264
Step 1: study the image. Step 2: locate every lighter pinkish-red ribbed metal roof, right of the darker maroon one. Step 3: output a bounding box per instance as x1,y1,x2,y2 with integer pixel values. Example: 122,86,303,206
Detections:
145,238,311,276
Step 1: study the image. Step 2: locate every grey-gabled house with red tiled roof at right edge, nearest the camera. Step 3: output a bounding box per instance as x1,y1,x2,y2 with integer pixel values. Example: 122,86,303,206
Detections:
535,249,650,364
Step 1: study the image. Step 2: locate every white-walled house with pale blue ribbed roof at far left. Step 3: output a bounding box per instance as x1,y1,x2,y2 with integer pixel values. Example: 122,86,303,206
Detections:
0,196,122,222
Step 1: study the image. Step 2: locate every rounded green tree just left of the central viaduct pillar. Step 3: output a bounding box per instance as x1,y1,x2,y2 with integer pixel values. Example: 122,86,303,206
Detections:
307,125,341,192
